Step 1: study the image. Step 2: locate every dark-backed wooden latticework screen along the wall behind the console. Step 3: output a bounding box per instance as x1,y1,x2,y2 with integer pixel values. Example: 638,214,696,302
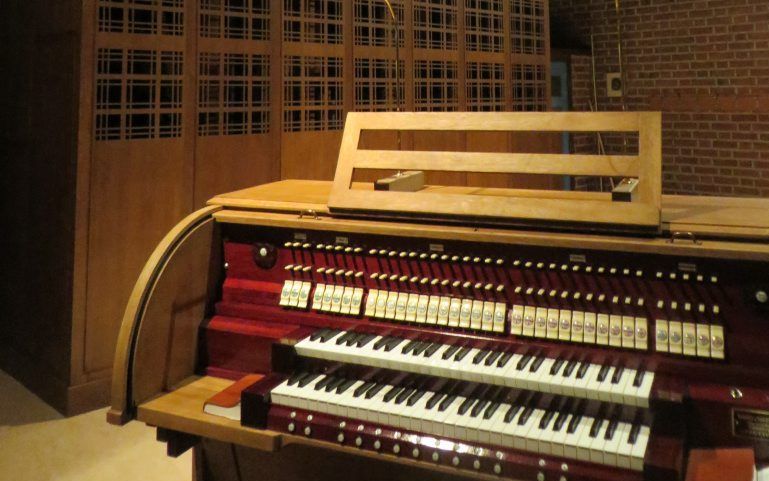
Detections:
93,0,549,182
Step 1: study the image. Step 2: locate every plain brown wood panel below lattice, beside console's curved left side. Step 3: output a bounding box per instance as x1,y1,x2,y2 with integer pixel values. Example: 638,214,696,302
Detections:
84,139,191,376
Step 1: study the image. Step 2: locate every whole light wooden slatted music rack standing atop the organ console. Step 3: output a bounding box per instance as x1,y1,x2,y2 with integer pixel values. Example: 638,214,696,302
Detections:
328,112,662,228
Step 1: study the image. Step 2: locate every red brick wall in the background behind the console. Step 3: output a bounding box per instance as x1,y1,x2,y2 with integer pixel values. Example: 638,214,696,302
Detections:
550,0,769,196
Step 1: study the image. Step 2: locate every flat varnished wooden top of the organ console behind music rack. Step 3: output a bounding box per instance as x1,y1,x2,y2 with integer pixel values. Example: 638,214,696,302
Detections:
209,180,769,239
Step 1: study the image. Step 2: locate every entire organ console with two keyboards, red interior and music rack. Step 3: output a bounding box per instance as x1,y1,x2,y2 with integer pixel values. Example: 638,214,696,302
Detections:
108,113,769,481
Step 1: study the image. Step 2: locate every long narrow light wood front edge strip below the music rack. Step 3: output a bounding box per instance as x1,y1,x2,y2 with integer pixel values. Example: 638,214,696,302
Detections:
214,209,769,261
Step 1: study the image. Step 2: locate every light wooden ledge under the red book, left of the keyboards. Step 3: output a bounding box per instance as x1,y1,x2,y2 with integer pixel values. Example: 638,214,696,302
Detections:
136,376,281,451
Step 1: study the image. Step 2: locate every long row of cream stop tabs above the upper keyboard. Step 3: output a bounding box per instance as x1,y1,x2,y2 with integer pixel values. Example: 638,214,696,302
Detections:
279,280,725,359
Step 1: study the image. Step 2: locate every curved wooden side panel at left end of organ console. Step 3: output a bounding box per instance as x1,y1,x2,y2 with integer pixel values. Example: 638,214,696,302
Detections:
107,206,221,425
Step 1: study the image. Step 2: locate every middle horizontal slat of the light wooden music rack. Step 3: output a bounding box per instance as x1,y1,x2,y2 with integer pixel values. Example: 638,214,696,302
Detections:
354,150,638,177
